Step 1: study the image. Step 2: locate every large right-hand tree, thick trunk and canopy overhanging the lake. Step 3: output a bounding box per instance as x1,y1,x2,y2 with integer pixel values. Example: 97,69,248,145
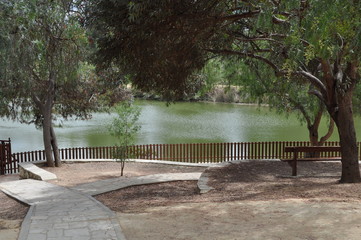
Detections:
89,0,361,182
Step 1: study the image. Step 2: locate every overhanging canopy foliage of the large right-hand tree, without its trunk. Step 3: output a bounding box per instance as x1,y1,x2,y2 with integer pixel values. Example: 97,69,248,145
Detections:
88,0,361,100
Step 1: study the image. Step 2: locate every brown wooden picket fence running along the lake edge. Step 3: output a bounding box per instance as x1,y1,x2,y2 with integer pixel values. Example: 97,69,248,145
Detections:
1,141,361,174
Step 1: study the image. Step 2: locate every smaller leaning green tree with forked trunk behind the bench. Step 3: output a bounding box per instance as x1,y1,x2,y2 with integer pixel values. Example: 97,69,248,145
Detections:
232,60,335,146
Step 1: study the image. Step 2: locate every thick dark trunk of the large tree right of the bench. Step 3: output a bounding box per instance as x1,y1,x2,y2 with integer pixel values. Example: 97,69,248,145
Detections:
334,93,361,183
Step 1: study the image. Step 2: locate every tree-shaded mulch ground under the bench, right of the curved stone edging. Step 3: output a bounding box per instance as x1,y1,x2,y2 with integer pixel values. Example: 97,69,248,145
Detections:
208,161,361,201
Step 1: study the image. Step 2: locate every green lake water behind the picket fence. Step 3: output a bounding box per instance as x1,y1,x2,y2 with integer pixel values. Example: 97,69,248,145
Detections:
0,101,354,152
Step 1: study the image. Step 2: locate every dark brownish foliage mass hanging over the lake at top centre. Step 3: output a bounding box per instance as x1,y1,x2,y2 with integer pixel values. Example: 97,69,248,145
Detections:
88,0,229,99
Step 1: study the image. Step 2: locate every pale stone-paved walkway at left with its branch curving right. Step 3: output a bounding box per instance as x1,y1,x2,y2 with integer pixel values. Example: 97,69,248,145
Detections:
0,172,201,240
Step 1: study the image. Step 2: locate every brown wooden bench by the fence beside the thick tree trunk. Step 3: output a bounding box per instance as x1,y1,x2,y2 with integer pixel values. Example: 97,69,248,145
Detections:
281,146,341,176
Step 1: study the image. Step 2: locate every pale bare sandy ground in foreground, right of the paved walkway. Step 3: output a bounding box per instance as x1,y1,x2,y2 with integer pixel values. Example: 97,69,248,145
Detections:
118,200,361,240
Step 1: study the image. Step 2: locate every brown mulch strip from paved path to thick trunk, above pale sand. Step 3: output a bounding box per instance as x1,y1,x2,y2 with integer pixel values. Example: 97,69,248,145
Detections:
96,161,361,213
